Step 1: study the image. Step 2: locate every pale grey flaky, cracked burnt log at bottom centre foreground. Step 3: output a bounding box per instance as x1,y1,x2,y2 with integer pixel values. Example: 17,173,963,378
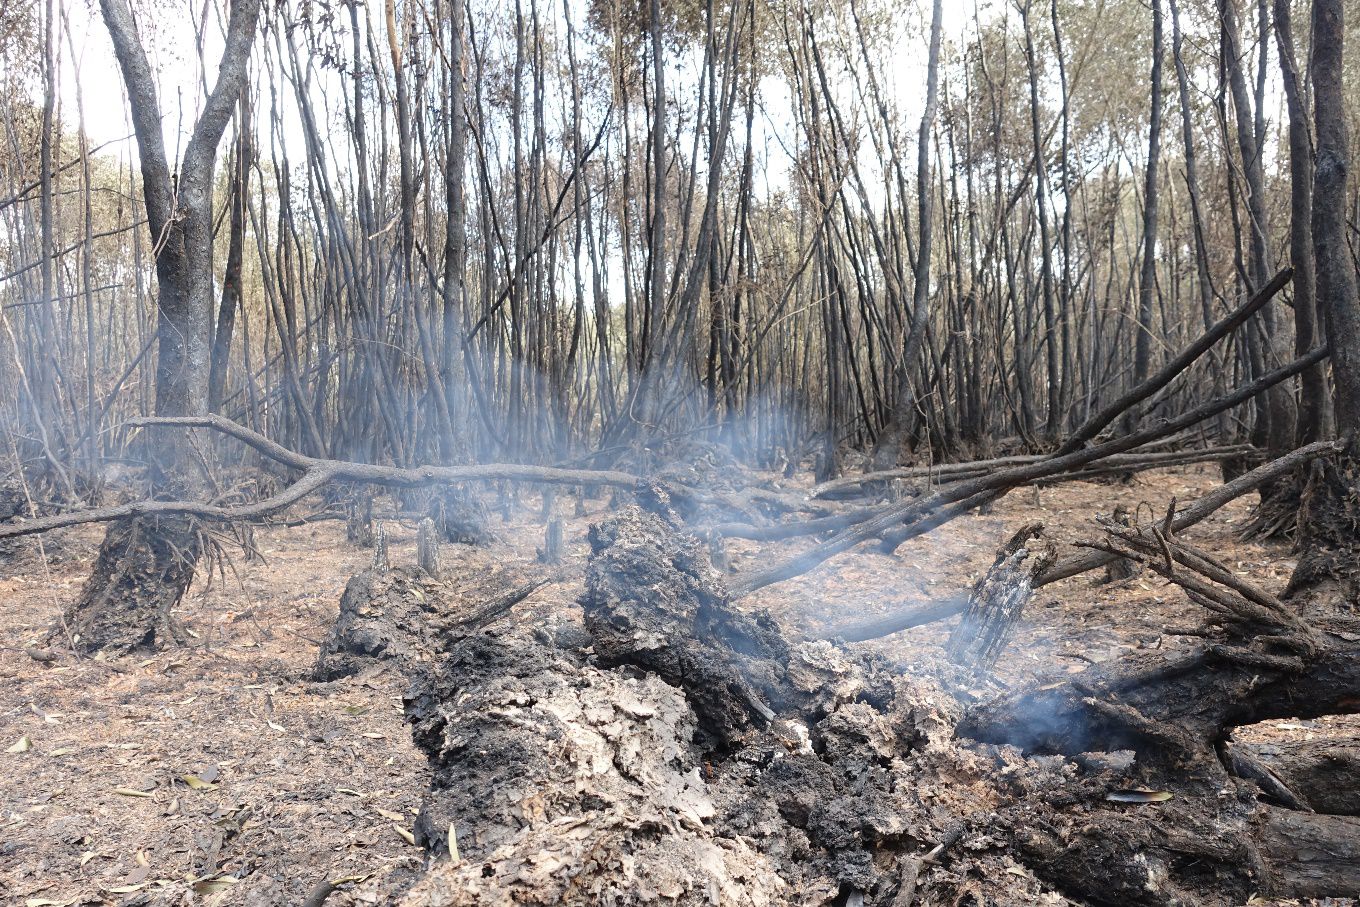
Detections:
404,634,786,907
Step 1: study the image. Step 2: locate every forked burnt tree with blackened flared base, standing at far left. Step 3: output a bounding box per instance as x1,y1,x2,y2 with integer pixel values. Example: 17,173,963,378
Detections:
65,0,260,653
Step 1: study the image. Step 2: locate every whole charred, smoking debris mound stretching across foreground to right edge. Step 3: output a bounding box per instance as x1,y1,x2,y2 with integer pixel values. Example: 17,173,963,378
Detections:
359,499,1360,907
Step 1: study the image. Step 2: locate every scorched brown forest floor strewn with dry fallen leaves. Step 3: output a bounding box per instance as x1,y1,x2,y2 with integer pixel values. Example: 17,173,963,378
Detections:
0,468,1360,907
